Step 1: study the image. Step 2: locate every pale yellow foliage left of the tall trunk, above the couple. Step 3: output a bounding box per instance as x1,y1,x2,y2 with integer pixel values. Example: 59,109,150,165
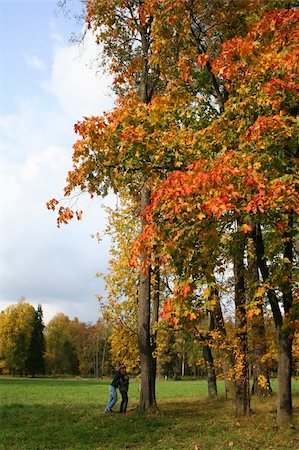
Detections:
99,197,140,371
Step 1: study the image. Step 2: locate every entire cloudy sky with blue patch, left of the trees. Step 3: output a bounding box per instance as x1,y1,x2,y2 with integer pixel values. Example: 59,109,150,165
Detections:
0,0,117,323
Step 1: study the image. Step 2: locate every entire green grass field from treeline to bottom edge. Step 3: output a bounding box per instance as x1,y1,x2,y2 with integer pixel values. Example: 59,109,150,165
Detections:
0,378,299,450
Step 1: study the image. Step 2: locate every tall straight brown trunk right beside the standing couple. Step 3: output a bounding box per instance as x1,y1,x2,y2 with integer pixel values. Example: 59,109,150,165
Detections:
138,184,156,412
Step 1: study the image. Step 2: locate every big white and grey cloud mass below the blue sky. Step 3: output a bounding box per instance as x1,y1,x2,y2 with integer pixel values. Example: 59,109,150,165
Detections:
0,25,113,321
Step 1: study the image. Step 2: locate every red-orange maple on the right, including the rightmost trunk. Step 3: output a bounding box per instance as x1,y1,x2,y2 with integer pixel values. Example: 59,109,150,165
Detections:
136,10,298,424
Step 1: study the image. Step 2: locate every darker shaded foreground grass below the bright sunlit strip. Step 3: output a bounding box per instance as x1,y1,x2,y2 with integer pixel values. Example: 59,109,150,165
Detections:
0,397,299,450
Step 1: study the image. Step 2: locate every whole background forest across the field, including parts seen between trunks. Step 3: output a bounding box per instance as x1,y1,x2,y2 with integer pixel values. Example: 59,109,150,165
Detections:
0,299,299,384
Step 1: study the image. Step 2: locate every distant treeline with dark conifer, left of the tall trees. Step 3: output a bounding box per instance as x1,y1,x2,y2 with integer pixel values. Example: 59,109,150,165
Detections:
0,300,111,377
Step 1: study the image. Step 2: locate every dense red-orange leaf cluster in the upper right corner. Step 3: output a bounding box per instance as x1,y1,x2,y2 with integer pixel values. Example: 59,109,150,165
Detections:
213,10,299,109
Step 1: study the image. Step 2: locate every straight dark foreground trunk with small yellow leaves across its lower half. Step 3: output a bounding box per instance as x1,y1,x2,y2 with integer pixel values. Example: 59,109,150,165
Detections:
234,227,250,417
